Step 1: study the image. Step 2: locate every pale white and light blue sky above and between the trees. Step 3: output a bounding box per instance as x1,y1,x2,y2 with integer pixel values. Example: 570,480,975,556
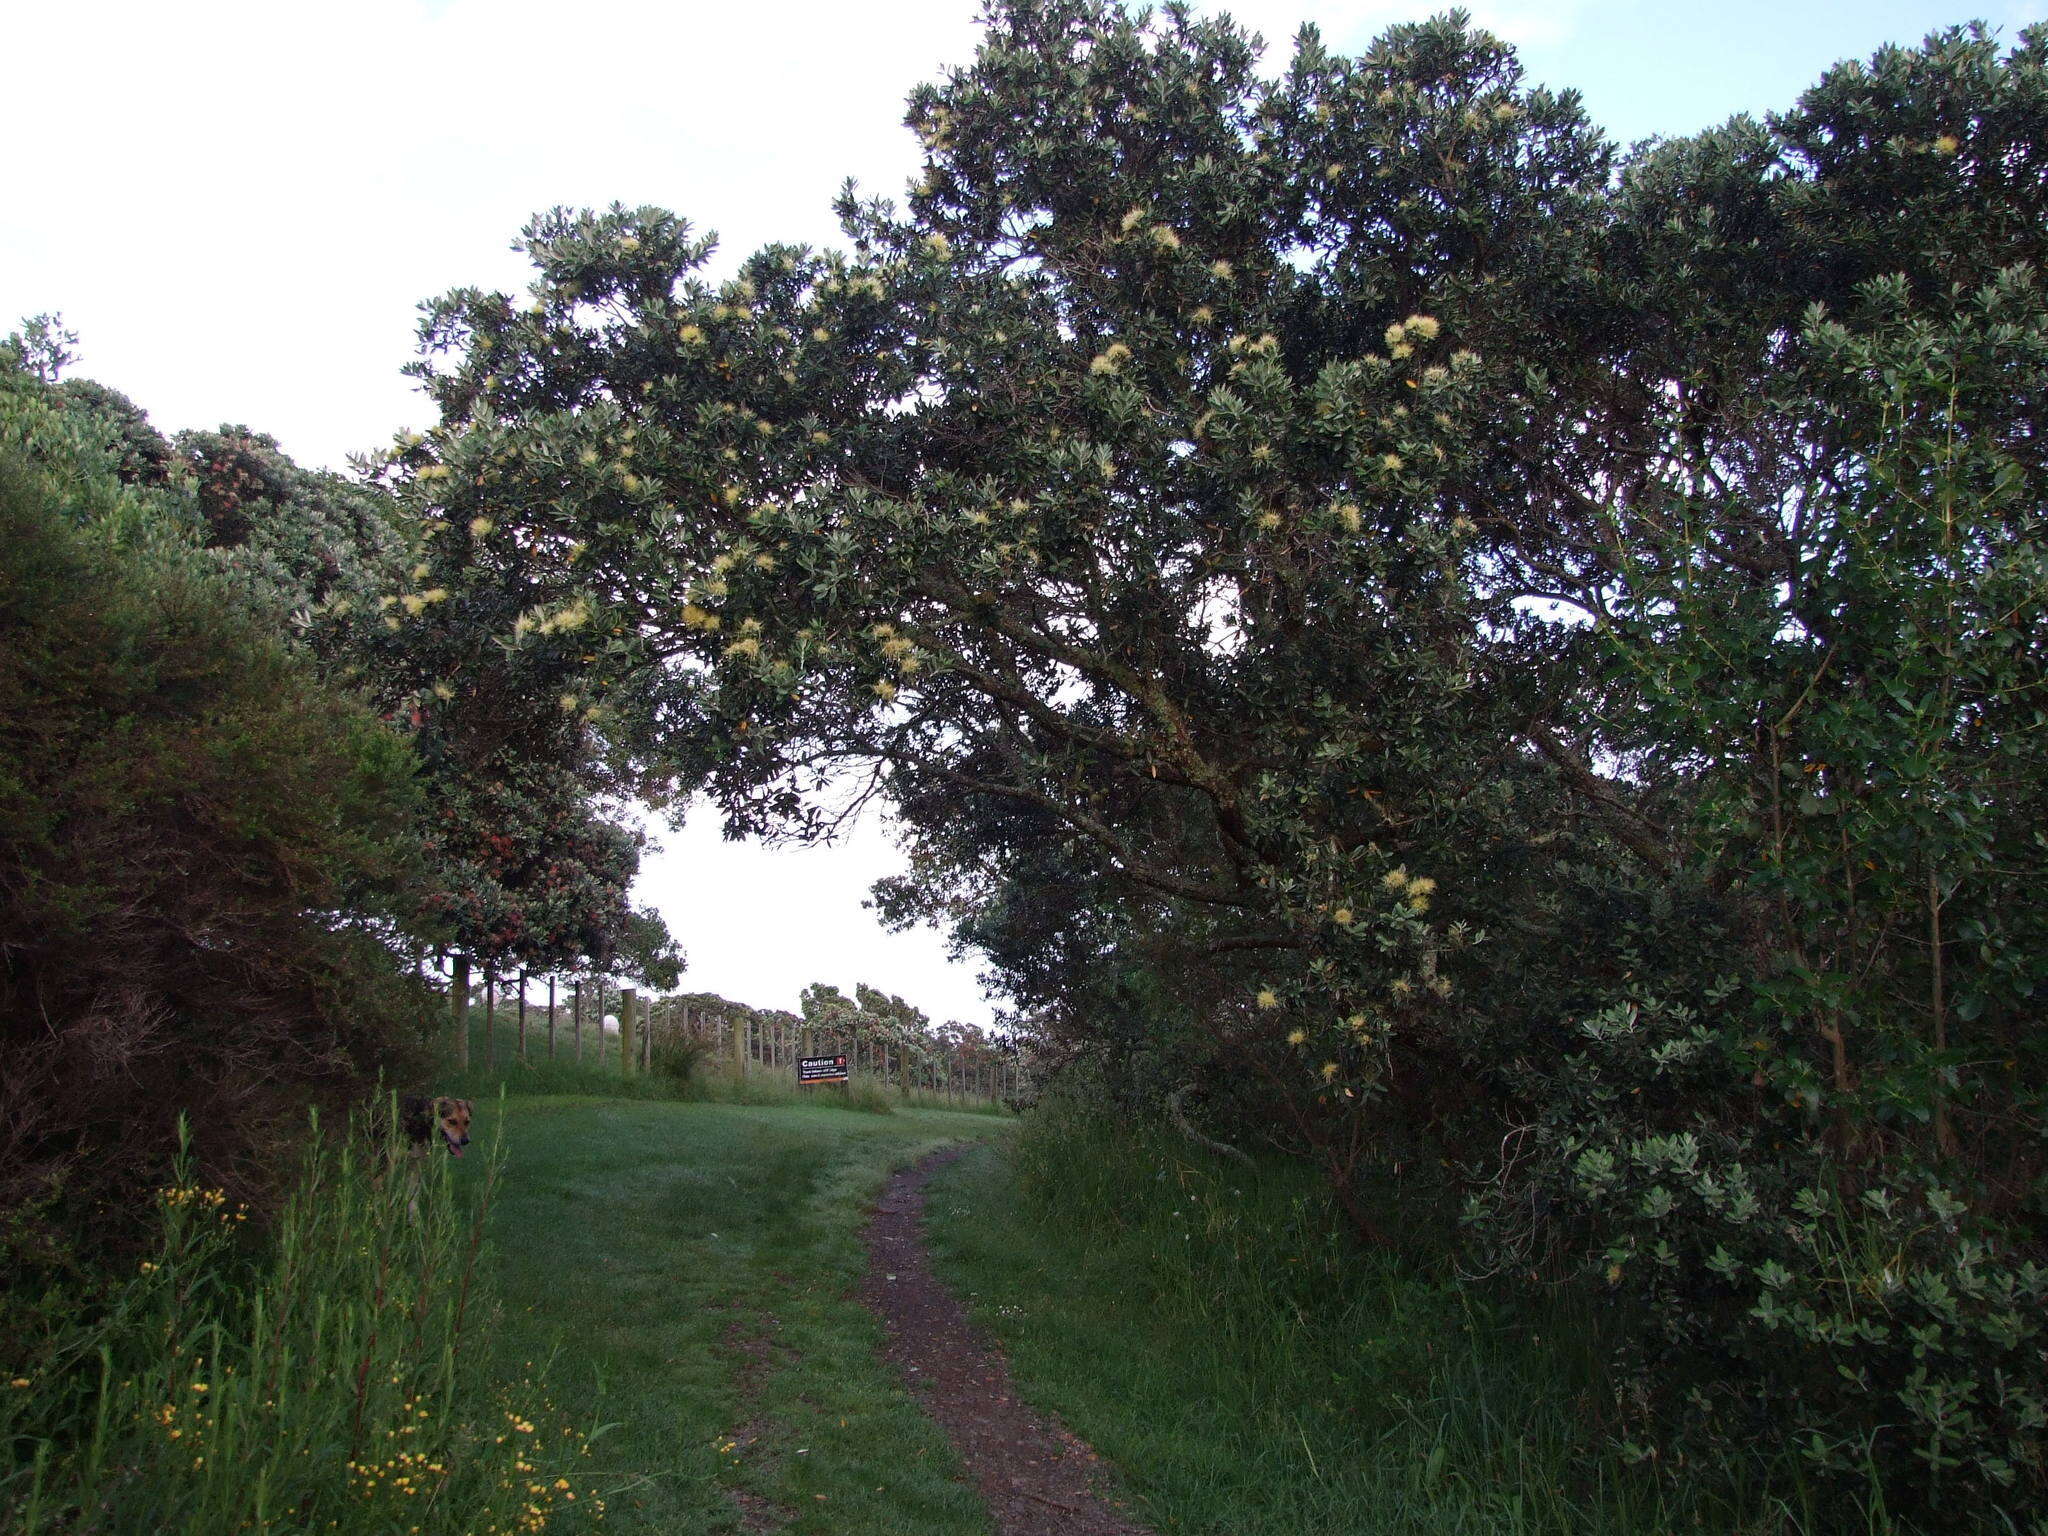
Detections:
12,0,2042,1036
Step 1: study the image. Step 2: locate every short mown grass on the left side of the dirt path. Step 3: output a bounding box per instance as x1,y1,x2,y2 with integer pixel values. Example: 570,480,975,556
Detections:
466,1096,997,1536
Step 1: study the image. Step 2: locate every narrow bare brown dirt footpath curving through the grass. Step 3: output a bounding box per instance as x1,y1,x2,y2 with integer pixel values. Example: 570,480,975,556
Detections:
860,1147,1149,1536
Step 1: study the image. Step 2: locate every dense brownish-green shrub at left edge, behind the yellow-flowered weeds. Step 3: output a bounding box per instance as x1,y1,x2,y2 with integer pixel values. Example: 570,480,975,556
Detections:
0,440,436,1257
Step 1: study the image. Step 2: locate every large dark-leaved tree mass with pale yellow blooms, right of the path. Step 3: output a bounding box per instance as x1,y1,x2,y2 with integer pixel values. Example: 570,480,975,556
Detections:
387,0,2048,1523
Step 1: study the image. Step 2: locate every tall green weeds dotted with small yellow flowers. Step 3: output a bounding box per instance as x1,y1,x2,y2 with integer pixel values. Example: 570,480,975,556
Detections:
0,1116,602,1536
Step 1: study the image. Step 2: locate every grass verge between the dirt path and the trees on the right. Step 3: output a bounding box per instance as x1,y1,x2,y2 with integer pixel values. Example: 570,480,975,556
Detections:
928,1110,1843,1536
